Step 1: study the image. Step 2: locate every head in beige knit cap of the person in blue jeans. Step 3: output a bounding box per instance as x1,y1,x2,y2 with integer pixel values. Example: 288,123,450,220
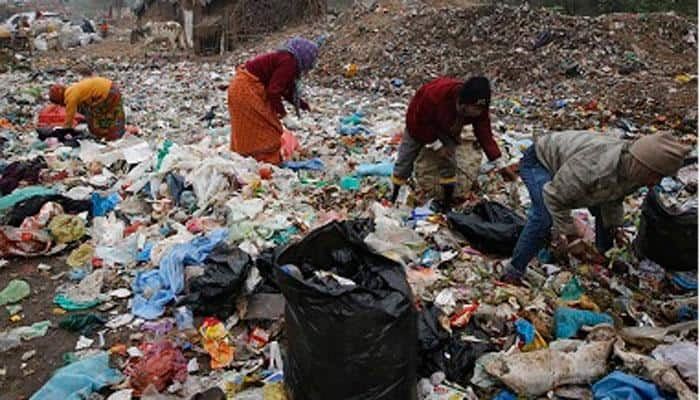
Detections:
630,133,691,186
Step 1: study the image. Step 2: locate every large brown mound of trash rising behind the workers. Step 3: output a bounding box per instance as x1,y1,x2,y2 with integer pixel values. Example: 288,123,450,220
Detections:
308,0,697,133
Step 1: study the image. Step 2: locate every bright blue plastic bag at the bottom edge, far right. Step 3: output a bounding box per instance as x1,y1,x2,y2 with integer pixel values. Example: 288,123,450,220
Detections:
592,371,664,400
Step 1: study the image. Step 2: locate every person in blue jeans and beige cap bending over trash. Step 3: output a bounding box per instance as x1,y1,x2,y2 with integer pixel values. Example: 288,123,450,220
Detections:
501,131,691,284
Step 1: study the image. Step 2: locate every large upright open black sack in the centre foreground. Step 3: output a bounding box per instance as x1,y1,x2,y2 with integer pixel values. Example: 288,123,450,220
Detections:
273,222,418,400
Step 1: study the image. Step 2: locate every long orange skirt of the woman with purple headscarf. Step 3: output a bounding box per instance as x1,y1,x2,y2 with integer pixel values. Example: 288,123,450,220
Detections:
228,67,283,164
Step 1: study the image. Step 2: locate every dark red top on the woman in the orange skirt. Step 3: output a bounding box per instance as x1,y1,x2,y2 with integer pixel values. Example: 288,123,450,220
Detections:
245,51,308,116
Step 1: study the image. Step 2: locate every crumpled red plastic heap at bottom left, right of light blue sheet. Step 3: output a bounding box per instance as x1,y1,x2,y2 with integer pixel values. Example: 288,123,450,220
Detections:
124,340,187,396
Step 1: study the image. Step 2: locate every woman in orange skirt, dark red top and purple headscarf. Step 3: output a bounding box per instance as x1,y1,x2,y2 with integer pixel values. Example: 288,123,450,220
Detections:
228,37,318,164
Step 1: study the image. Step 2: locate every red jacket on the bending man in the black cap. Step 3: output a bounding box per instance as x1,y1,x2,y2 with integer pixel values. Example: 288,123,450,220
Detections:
406,78,501,161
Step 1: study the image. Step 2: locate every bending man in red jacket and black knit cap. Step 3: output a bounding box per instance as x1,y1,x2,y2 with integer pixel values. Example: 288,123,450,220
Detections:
391,76,516,211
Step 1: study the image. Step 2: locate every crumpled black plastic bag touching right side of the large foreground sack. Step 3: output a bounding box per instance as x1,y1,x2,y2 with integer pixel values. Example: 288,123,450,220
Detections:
418,306,497,385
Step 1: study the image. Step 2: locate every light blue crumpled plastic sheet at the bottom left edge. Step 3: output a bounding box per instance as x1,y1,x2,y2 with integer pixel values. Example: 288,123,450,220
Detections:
30,352,124,400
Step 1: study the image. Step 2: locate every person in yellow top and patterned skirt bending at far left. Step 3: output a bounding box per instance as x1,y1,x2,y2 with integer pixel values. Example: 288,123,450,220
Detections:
49,77,126,140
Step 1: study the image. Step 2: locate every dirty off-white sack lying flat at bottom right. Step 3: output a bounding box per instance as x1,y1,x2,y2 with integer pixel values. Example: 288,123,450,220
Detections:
484,340,613,396
